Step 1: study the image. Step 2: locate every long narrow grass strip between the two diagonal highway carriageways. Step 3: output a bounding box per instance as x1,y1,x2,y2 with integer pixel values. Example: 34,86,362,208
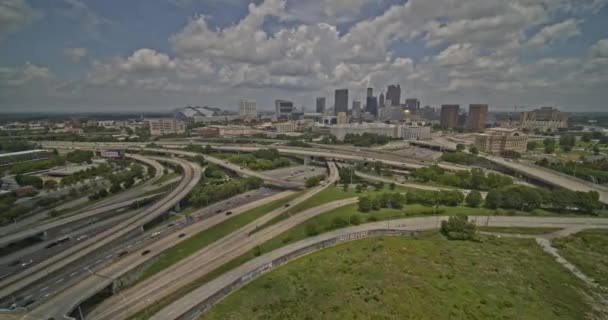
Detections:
138,193,300,282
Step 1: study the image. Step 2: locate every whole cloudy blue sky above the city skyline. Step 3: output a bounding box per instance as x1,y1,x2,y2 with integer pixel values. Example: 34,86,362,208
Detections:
0,0,608,112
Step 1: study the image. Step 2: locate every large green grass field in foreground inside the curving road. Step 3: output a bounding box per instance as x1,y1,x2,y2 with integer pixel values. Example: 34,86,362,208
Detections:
201,233,591,320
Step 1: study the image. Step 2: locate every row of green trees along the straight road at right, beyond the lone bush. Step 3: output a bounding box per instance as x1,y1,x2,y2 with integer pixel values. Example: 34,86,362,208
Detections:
484,185,601,214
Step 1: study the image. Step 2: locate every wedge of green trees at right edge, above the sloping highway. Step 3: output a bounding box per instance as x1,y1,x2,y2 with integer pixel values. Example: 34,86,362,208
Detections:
536,158,608,184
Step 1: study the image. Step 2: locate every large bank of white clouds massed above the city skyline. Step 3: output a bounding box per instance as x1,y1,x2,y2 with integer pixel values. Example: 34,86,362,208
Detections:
0,0,608,109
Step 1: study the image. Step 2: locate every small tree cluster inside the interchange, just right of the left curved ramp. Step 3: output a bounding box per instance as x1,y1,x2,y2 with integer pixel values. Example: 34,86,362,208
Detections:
188,177,264,207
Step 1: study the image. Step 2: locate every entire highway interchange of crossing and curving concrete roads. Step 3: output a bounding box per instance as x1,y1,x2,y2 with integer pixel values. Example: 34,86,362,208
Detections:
0,142,608,319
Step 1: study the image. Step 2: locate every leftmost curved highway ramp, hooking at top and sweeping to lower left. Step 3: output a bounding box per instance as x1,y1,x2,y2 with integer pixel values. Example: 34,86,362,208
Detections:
0,159,201,308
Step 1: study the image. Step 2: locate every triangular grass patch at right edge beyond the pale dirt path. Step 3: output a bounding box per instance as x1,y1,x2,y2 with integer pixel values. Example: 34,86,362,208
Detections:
553,229,608,287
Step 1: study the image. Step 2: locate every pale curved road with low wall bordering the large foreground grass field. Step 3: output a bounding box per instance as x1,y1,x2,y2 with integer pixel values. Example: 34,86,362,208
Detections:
150,216,608,320
